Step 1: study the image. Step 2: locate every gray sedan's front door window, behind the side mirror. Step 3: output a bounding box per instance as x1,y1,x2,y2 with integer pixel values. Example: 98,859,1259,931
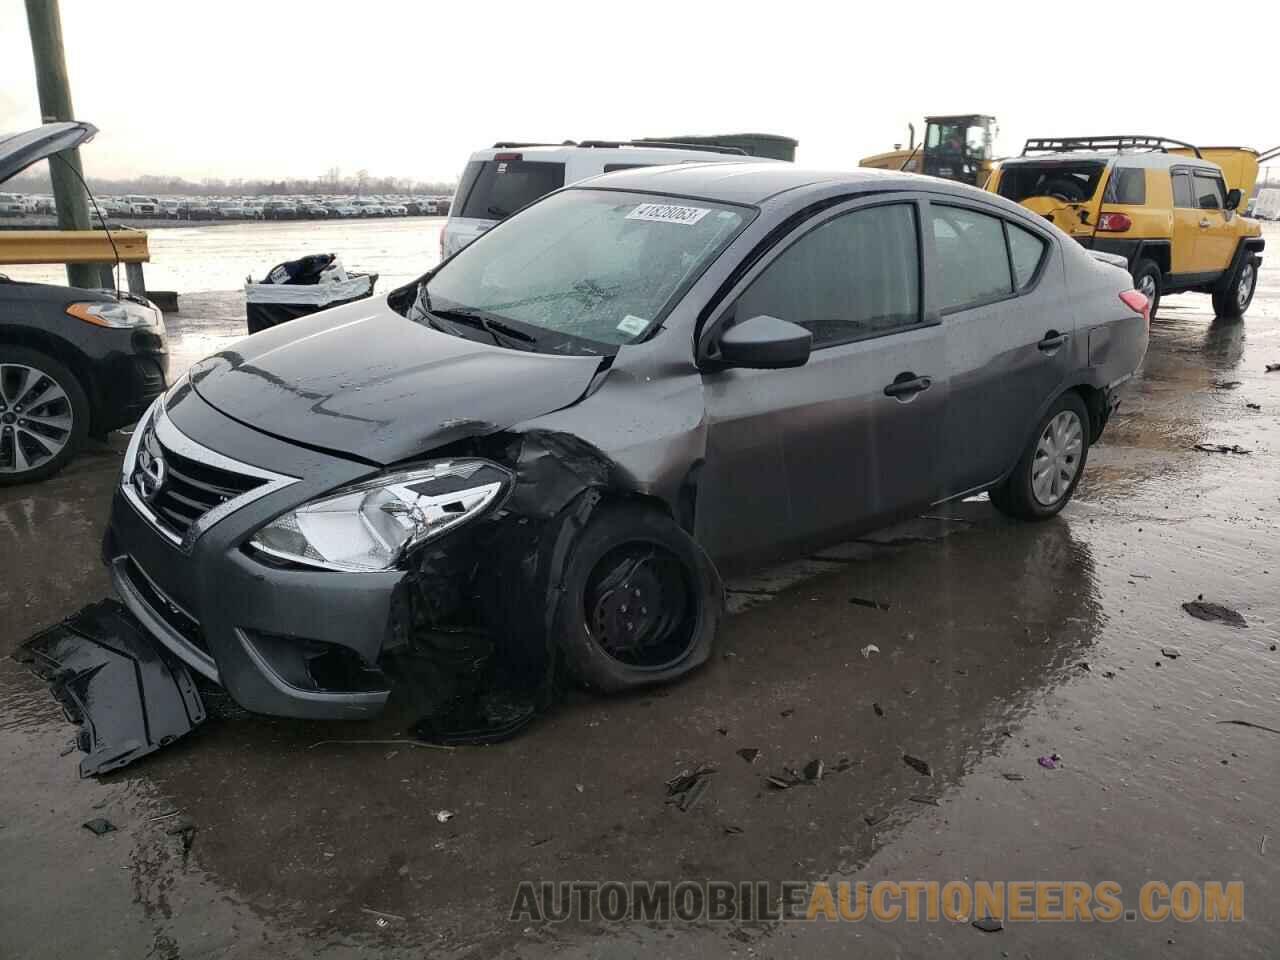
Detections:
735,204,922,348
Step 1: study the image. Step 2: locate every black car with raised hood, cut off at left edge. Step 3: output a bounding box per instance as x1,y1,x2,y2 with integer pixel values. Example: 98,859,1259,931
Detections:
0,123,169,485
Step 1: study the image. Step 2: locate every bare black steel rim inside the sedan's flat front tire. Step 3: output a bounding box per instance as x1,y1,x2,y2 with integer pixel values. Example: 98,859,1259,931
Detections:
584,543,699,669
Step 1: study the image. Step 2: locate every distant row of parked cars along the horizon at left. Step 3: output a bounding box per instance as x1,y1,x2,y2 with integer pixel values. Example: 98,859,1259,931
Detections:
0,193,451,220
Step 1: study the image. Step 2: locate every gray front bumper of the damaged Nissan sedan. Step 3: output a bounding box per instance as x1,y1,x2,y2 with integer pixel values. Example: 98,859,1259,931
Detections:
102,389,403,718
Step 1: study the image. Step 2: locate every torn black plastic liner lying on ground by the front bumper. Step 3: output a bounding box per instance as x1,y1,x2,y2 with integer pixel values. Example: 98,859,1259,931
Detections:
14,600,205,777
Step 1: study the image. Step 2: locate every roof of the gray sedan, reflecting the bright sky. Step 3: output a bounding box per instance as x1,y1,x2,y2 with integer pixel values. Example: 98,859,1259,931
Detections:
570,160,967,205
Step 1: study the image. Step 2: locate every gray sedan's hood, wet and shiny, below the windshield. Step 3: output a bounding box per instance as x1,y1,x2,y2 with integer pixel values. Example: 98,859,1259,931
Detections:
191,297,603,465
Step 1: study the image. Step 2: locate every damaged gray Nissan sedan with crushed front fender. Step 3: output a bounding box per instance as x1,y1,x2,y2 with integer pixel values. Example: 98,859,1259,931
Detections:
104,163,1147,718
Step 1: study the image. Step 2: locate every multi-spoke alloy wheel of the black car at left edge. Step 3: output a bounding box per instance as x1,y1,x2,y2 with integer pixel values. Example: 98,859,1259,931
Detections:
0,344,88,485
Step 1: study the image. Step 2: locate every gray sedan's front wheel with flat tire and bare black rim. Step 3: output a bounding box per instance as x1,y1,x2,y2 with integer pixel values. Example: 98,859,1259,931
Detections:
554,506,723,692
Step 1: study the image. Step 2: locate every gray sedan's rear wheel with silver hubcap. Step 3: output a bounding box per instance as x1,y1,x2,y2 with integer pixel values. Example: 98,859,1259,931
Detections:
991,392,1089,520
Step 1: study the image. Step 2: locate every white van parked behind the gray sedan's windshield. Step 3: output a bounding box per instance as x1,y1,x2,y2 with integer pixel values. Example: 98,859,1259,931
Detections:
440,140,756,259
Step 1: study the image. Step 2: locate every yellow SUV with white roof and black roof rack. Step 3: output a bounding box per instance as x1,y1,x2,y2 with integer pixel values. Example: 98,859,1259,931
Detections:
987,136,1266,317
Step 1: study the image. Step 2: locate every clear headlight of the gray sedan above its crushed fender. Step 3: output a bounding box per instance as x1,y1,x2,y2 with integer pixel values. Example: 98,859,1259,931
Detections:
250,460,511,572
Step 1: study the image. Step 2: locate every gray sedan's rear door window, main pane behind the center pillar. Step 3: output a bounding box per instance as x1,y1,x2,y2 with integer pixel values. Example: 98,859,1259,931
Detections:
929,204,1008,312
